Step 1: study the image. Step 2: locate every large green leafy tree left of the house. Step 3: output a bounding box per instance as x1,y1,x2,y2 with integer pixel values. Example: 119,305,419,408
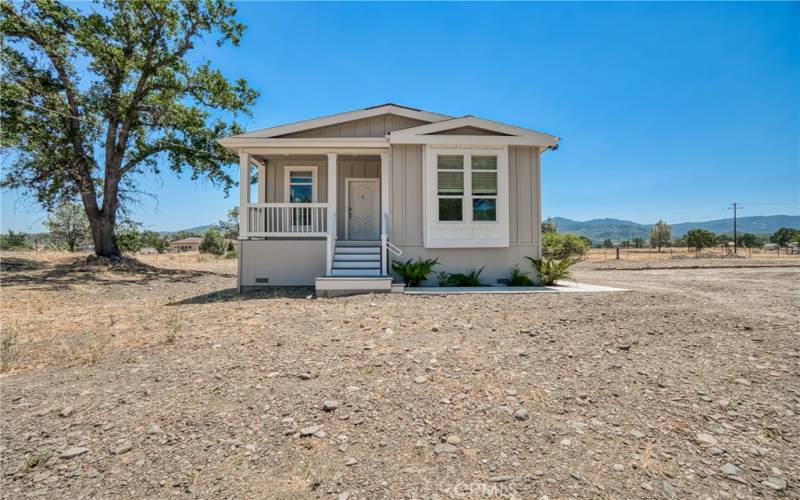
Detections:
0,0,258,257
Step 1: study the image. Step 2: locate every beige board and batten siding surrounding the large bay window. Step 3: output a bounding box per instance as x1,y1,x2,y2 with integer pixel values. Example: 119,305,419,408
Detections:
389,145,541,284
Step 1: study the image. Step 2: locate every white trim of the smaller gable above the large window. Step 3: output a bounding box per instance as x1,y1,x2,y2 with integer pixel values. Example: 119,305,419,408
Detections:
389,116,559,147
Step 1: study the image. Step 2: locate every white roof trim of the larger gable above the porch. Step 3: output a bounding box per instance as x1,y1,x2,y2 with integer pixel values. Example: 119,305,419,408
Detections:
221,104,452,140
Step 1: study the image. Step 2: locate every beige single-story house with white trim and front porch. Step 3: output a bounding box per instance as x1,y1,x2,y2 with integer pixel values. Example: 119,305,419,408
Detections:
220,104,559,294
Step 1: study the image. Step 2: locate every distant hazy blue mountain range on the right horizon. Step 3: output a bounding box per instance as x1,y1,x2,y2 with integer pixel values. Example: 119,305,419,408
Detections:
553,215,800,242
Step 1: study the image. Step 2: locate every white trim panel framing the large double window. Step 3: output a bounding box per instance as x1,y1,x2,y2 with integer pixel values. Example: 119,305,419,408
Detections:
423,144,510,248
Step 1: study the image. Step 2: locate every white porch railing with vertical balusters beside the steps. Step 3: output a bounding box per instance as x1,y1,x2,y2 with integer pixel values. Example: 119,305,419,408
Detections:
245,203,328,237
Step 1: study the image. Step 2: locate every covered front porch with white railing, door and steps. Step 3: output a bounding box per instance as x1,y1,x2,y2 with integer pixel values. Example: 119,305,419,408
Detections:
239,147,391,277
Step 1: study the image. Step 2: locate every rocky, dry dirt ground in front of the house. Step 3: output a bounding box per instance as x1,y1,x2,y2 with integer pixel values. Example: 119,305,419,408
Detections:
0,254,800,499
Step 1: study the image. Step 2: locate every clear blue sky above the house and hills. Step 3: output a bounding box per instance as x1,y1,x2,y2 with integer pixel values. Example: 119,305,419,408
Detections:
2,2,800,231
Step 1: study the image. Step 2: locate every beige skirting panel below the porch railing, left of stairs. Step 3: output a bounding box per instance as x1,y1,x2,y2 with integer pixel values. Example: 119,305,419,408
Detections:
239,239,326,287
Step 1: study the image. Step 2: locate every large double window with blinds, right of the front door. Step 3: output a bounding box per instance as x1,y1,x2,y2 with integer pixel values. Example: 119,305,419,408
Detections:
436,154,497,222
